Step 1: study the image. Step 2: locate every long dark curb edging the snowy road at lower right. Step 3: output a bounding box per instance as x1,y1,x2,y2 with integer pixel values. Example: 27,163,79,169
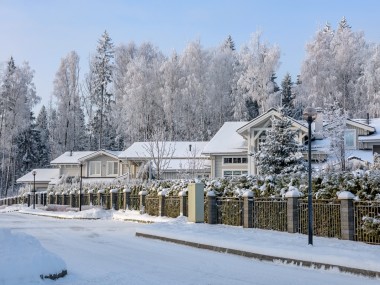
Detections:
136,232,380,278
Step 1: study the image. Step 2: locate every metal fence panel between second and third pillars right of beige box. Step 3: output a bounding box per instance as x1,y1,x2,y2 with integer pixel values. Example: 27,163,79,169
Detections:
253,199,287,232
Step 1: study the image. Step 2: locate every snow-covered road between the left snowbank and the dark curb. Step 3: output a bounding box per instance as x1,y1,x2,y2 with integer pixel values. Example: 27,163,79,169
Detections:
0,212,379,285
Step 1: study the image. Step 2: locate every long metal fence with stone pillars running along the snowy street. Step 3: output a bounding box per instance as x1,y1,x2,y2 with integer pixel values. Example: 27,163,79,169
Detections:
0,189,380,244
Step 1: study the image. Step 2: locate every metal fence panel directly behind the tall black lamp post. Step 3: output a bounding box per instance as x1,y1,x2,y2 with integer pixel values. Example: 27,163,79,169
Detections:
298,200,341,238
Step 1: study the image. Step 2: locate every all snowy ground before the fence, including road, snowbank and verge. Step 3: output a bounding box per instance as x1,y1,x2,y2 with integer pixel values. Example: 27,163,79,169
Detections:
0,204,380,285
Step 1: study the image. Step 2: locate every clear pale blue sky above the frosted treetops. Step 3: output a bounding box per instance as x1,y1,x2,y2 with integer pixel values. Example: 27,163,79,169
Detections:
0,0,380,111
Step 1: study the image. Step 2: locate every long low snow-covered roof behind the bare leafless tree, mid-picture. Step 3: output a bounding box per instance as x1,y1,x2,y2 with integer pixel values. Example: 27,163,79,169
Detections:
119,141,207,159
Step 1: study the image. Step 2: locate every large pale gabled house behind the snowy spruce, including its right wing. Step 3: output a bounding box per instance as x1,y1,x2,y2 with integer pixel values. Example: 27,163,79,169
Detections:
202,108,380,177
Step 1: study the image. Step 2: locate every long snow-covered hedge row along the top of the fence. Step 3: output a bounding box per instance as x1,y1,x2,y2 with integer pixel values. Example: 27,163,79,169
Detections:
39,170,380,201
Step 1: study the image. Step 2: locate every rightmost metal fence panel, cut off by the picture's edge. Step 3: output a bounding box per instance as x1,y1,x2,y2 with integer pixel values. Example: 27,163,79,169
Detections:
354,202,380,244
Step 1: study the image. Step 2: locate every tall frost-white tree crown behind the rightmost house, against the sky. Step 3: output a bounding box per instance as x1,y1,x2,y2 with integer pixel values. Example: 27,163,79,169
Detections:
301,18,368,117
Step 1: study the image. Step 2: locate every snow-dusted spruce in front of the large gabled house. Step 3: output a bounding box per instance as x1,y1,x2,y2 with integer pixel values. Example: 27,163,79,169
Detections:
254,111,306,175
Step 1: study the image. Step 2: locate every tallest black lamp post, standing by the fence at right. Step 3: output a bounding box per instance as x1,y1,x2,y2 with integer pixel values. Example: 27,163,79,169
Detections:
303,107,317,245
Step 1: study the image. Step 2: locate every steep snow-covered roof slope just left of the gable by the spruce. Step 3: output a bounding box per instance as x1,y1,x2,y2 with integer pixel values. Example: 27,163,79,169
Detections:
202,122,248,154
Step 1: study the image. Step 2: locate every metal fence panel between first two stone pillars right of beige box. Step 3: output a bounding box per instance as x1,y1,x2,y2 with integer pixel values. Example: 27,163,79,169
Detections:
216,198,243,226
